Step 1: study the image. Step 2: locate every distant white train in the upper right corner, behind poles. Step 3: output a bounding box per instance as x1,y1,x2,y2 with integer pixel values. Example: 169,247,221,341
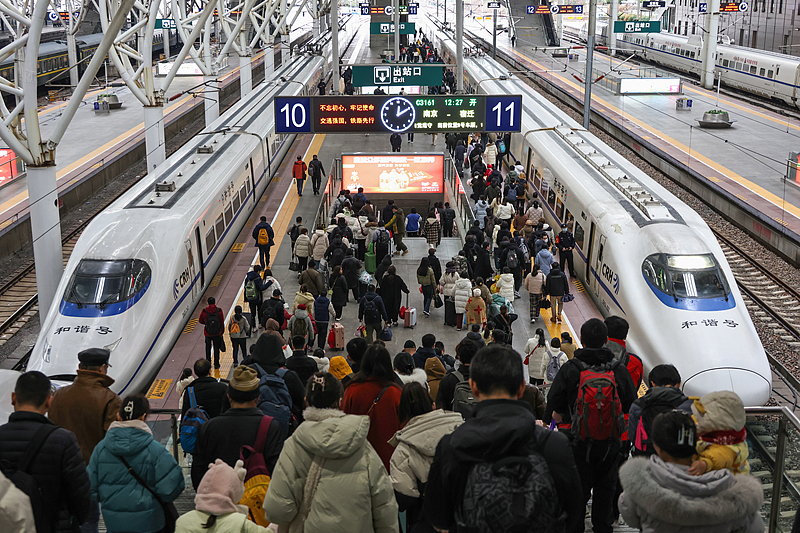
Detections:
564,22,800,107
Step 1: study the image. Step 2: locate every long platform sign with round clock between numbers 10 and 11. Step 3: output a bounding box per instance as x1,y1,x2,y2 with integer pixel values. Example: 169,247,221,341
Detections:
274,94,522,133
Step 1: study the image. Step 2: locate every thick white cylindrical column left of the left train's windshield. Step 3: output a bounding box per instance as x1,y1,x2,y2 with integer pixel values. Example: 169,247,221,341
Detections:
27,165,64,317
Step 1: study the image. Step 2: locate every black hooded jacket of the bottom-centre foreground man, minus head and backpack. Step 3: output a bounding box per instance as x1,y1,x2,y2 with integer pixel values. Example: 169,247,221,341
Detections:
425,400,584,531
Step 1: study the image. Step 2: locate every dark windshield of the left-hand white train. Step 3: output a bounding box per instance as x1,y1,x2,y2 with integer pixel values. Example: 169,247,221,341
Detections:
64,259,150,306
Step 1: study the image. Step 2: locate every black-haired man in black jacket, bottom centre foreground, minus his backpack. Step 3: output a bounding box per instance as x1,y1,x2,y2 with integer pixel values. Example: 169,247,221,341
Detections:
424,344,585,531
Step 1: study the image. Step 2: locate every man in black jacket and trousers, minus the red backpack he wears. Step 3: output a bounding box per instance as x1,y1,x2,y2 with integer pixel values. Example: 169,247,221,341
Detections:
547,318,636,533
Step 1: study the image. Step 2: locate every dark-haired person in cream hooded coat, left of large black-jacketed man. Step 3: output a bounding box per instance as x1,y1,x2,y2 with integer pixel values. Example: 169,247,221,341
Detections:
389,380,464,532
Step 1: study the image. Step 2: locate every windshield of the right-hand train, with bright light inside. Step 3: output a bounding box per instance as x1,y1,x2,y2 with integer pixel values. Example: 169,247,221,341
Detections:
642,254,730,299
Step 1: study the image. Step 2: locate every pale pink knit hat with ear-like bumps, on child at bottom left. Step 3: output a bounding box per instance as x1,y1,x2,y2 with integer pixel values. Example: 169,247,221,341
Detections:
194,458,247,516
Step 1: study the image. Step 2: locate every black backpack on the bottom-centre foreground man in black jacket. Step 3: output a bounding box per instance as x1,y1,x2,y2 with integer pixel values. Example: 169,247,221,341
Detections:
456,435,566,533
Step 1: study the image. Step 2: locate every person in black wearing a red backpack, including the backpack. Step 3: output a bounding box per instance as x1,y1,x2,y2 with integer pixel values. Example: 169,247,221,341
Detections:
545,318,636,533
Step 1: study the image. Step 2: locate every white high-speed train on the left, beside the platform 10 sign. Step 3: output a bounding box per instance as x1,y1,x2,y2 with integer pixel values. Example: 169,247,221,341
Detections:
27,20,355,393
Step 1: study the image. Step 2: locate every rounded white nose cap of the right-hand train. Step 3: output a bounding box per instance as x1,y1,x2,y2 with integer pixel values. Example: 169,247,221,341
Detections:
683,368,772,406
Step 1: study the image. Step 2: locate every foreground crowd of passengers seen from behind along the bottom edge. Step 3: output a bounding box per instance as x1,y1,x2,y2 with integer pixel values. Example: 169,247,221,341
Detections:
0,317,764,533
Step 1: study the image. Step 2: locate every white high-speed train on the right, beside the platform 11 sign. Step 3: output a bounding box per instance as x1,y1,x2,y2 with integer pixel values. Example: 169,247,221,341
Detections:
428,17,772,405
